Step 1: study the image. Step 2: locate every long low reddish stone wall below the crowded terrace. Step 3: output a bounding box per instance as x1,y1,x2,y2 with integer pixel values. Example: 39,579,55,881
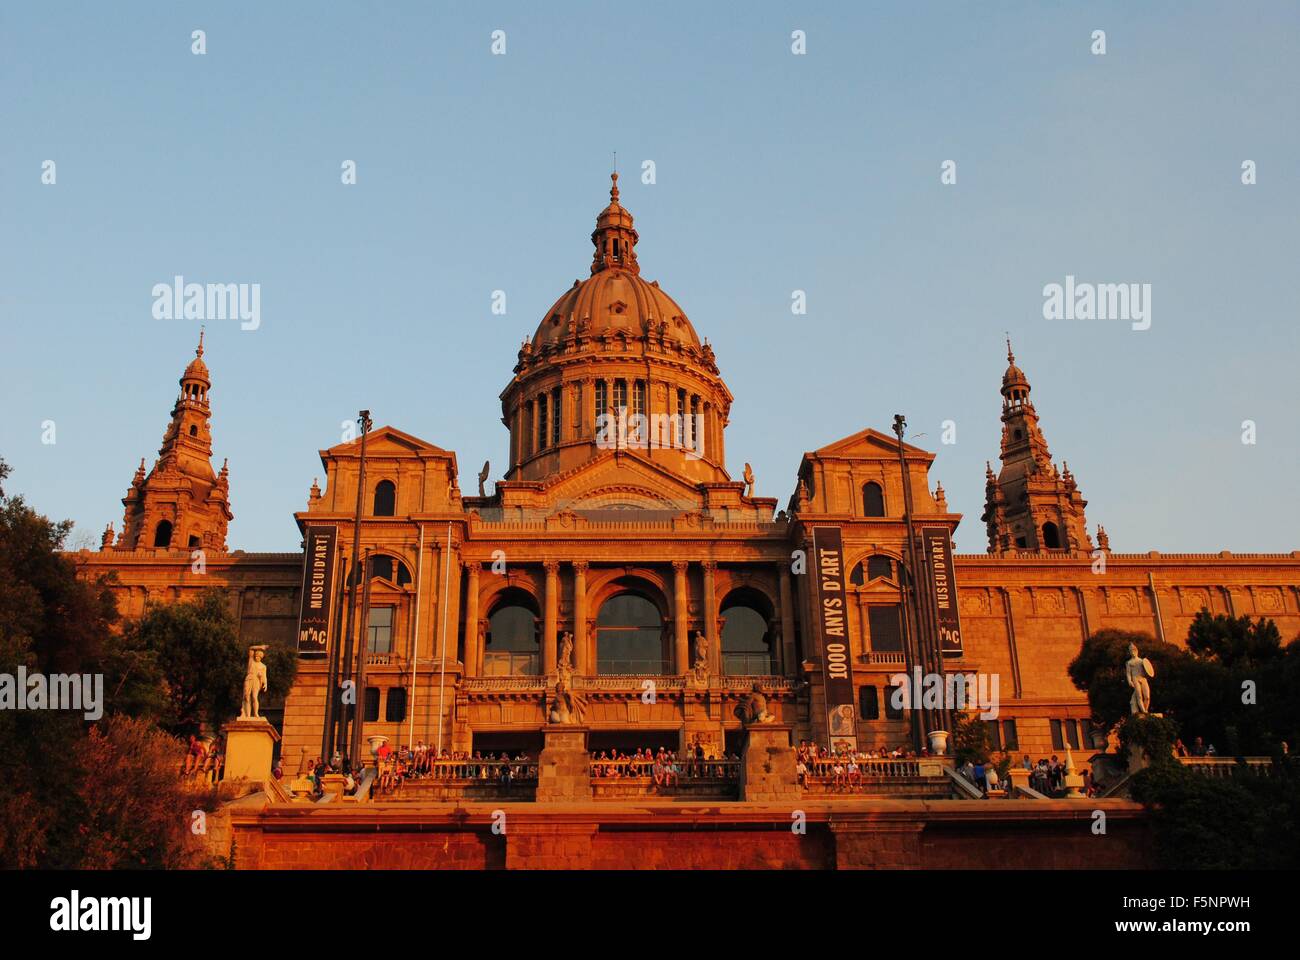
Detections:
233,800,1152,870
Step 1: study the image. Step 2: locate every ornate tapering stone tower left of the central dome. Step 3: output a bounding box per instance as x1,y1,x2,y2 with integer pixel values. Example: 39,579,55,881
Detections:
104,333,234,553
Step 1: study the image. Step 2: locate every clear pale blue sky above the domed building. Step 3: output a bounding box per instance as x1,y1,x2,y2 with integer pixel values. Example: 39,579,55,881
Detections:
0,3,1300,552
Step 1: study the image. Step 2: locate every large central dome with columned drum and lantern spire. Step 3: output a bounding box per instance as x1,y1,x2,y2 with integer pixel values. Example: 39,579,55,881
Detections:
501,173,732,483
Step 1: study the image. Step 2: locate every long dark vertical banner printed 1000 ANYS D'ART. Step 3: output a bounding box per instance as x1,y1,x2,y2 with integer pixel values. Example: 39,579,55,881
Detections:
813,527,858,751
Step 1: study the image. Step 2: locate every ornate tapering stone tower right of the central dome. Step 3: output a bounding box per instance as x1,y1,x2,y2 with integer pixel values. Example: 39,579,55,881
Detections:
980,340,1092,557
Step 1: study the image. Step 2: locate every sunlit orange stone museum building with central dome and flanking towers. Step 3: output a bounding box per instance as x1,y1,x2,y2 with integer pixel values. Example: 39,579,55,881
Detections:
73,175,1300,764
